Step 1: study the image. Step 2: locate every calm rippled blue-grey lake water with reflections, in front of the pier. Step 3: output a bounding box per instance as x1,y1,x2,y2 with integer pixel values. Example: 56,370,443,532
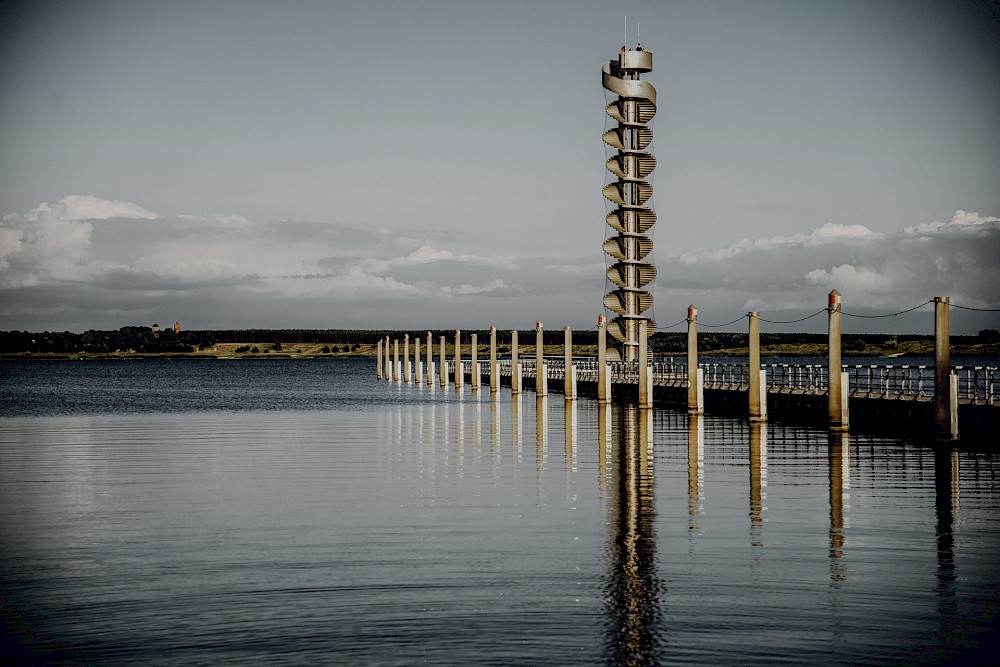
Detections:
0,359,1000,665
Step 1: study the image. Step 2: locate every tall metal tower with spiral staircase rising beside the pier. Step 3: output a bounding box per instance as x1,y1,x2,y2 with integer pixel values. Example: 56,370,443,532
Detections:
601,45,656,360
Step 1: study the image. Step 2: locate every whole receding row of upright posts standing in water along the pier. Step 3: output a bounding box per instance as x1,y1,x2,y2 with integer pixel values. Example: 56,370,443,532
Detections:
377,290,958,440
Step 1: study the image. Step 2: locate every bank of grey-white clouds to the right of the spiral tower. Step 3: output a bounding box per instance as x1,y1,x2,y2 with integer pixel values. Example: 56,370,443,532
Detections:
656,210,1000,326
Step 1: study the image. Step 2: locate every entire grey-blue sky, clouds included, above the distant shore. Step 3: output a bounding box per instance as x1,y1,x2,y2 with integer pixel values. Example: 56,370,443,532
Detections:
0,0,1000,334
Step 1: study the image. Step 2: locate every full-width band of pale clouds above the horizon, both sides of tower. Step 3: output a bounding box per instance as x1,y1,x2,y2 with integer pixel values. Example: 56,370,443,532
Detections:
0,197,1000,333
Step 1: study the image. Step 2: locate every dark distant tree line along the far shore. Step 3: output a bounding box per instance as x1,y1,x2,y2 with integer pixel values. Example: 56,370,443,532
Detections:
0,326,1000,354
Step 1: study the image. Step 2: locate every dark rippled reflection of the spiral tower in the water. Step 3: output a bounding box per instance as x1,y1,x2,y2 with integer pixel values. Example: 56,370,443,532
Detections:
598,405,662,665
